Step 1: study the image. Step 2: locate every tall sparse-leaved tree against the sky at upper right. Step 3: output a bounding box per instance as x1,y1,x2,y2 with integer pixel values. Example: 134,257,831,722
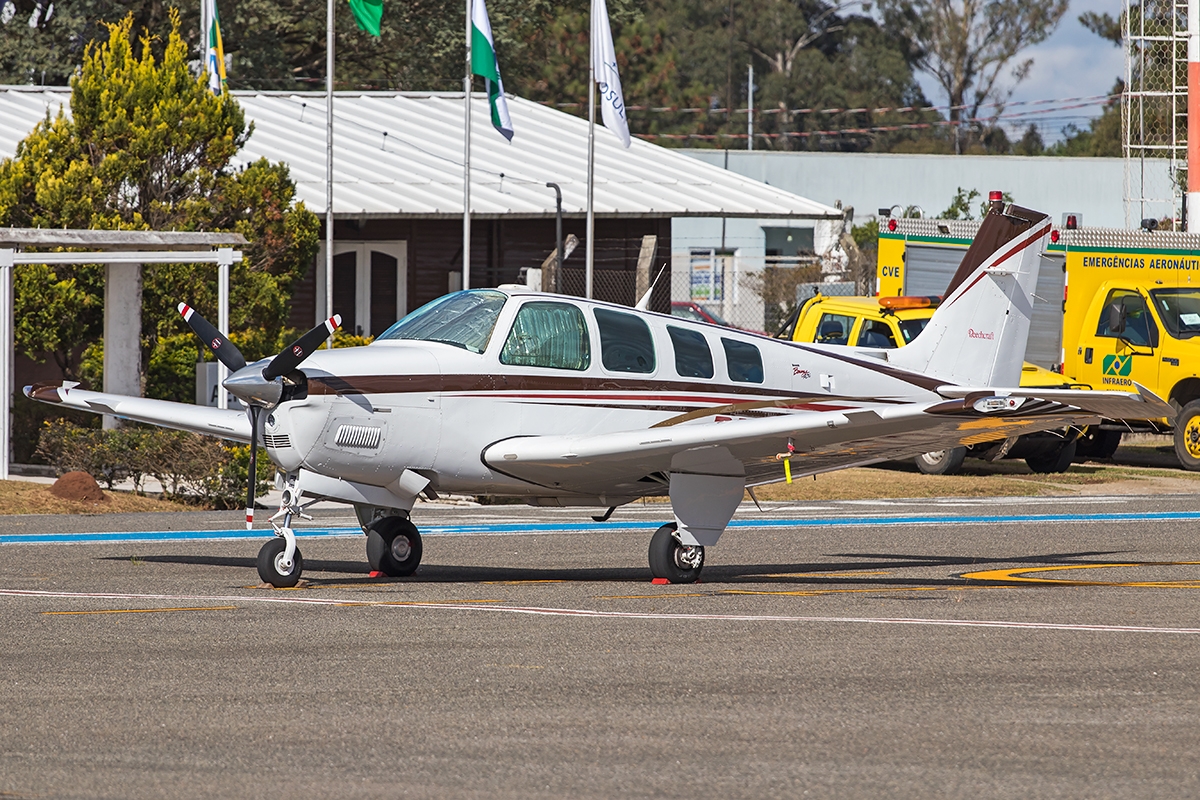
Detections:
880,0,1067,151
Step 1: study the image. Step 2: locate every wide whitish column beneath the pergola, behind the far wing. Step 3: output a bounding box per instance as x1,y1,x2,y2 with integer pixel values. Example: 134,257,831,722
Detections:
104,264,142,429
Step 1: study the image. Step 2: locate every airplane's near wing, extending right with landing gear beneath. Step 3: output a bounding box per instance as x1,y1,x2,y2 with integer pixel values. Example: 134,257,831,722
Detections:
482,387,1169,497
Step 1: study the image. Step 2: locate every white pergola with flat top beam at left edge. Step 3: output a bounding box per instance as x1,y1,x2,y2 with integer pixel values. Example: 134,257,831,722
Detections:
0,228,246,480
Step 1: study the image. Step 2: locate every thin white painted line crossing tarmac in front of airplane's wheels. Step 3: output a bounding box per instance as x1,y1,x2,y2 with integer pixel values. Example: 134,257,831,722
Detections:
0,589,1200,634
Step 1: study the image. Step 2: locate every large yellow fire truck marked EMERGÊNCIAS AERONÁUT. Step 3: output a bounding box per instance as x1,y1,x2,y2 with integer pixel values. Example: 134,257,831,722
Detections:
876,215,1200,470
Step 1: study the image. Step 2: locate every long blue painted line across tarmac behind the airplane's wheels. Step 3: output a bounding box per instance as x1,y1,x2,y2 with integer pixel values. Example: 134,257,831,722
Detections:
7,509,1200,545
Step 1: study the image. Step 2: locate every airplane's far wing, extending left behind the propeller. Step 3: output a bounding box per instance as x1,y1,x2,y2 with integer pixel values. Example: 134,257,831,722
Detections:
25,384,250,443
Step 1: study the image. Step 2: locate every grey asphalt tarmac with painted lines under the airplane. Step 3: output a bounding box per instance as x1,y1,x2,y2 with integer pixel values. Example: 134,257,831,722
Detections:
0,495,1200,800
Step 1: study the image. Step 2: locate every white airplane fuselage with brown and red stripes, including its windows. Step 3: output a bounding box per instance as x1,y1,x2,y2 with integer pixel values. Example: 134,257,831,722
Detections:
263,290,940,497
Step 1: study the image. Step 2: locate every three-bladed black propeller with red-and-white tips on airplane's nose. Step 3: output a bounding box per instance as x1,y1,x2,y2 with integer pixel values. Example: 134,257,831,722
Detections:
179,302,342,530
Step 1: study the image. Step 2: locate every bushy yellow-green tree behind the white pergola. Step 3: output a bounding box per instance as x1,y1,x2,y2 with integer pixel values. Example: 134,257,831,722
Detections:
0,13,318,399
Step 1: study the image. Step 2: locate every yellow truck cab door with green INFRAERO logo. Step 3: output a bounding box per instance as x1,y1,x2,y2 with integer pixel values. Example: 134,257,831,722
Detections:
1075,289,1162,390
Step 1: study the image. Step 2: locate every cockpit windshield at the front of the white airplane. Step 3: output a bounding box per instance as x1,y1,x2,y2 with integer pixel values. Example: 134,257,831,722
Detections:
377,289,509,353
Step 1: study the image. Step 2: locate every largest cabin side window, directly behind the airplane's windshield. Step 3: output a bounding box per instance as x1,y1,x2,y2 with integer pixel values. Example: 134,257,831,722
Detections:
500,302,592,369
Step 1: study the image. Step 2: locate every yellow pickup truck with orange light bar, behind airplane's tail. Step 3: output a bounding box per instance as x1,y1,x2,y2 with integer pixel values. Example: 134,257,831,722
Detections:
785,294,1080,475
